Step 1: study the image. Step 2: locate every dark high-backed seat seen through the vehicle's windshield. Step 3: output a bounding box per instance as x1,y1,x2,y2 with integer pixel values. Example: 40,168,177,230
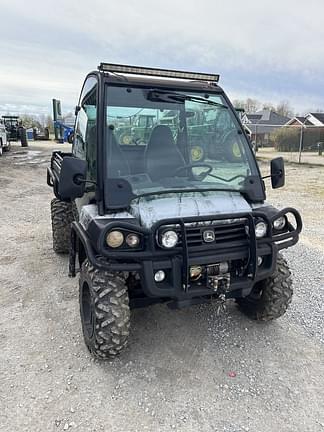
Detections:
144,125,185,181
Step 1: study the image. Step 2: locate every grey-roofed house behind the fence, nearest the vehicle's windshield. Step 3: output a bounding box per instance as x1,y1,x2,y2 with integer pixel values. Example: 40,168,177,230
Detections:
242,110,290,146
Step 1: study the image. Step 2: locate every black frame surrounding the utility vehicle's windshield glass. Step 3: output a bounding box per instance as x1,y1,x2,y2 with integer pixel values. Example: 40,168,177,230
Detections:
101,81,265,210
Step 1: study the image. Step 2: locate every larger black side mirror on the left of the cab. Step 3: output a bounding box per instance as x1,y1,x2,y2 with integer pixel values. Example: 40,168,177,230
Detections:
58,156,87,201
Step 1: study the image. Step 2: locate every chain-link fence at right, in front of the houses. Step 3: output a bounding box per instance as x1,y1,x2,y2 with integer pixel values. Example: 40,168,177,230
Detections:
244,123,324,165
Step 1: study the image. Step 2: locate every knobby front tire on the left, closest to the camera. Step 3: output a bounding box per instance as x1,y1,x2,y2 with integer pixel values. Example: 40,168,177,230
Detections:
79,260,130,359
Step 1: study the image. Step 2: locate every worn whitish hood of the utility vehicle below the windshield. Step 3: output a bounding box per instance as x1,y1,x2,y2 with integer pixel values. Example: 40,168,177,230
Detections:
129,191,252,228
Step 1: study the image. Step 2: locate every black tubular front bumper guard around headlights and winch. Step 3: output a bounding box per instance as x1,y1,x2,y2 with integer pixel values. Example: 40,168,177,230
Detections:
70,208,302,301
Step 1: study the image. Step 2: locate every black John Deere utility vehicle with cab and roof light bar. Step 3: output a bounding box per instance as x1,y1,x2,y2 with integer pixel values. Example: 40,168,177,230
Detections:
47,63,302,359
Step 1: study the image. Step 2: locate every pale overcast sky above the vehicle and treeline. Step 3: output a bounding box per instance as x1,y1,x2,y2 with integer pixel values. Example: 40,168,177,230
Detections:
0,0,324,113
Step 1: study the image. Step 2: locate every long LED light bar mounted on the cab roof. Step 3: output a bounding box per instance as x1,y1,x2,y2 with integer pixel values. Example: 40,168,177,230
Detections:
98,63,219,82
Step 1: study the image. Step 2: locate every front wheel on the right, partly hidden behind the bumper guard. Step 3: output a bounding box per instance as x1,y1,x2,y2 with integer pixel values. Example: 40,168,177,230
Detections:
237,254,293,321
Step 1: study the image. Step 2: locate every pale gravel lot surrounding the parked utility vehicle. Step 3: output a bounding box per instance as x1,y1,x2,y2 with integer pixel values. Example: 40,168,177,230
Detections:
0,144,324,432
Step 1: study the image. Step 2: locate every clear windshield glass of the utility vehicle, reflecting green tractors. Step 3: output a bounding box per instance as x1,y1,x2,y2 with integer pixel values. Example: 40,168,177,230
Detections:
106,86,258,195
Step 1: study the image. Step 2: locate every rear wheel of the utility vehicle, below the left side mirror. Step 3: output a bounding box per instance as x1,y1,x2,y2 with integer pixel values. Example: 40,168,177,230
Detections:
51,198,73,254
